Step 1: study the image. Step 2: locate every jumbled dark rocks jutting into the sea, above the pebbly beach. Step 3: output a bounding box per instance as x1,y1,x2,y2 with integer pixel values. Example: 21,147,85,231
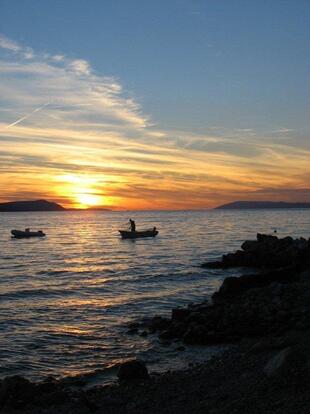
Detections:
139,234,310,345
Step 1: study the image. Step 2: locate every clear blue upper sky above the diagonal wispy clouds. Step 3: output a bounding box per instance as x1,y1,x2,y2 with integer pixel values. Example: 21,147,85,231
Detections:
0,0,310,132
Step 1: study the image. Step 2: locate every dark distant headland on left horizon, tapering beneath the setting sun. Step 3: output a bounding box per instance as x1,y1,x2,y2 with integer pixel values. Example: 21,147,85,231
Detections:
0,200,111,213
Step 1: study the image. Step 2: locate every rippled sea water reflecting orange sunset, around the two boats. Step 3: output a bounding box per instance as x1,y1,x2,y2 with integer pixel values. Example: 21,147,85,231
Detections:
0,210,310,382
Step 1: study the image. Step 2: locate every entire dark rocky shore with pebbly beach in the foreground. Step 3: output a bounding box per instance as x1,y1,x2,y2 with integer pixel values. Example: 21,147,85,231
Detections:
0,234,310,414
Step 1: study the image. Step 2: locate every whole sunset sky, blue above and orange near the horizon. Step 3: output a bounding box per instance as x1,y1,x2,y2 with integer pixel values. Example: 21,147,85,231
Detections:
0,0,310,209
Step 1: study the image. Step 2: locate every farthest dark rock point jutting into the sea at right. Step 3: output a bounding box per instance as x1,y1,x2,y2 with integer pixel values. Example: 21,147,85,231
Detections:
202,233,310,270
